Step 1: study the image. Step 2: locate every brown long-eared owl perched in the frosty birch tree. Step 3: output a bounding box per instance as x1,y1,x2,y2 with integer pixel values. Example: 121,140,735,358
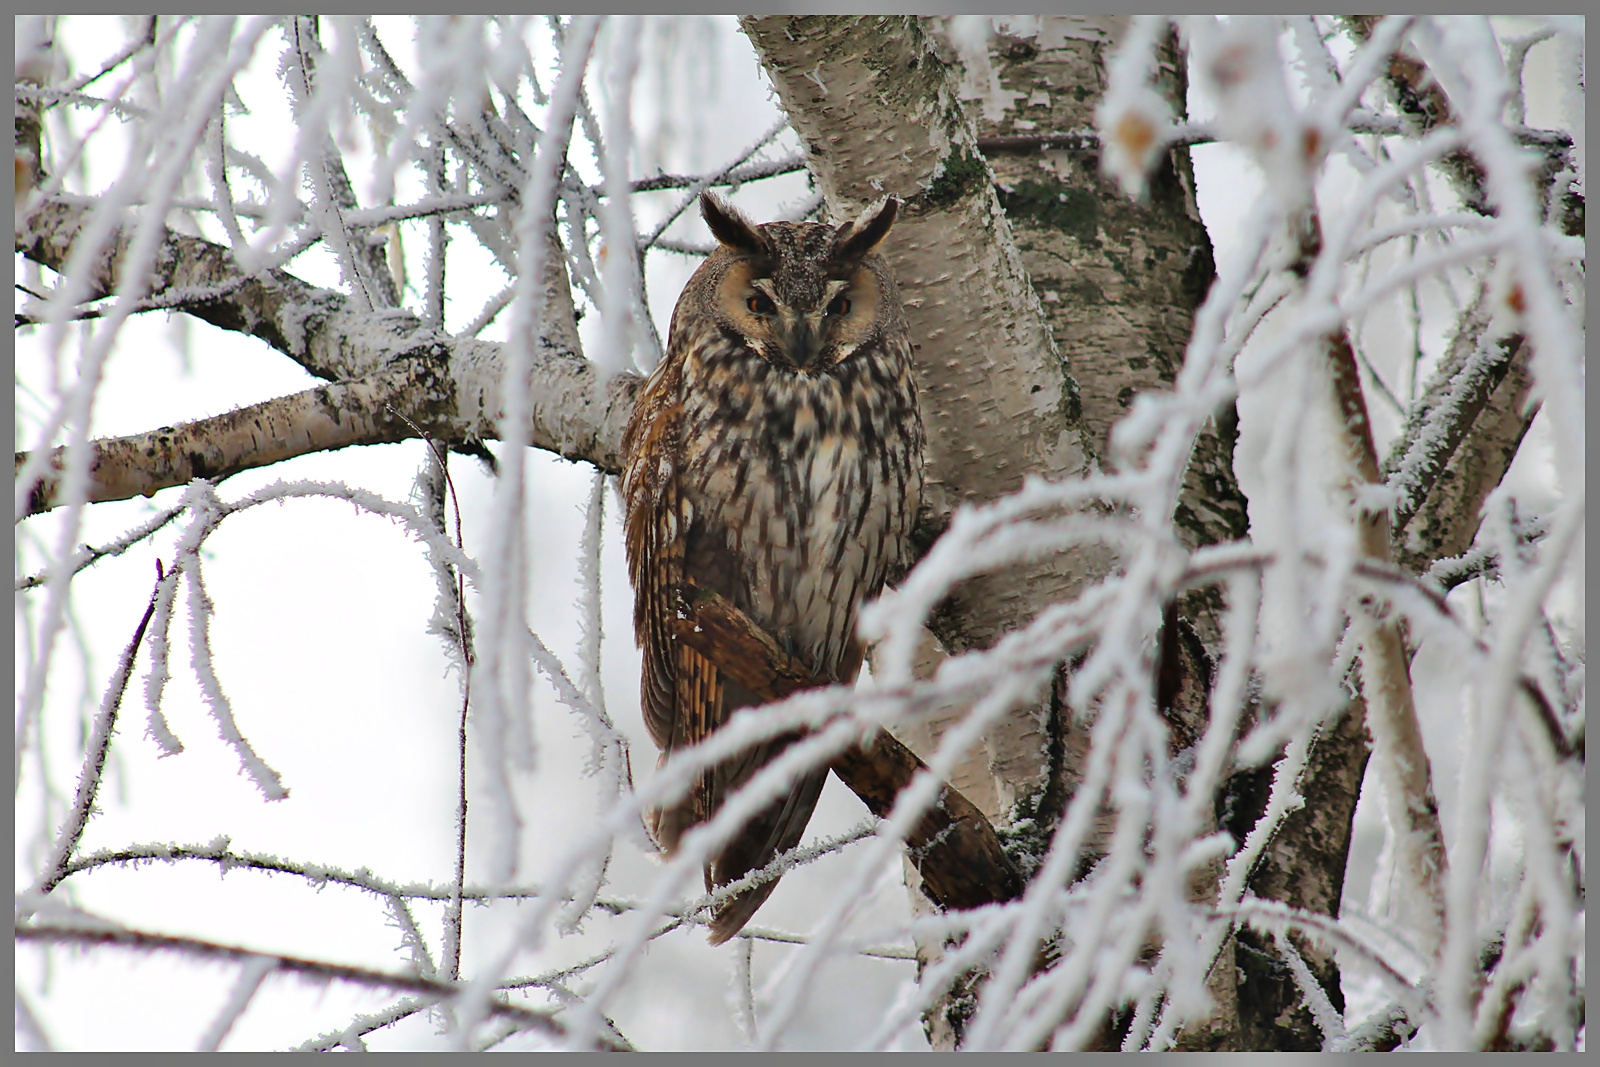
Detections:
622,194,923,944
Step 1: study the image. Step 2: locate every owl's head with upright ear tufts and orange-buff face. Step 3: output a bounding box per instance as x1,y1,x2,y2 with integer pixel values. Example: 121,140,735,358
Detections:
685,192,904,374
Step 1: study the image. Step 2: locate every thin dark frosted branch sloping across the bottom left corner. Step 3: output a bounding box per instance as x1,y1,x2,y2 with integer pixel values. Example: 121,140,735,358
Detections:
16,925,632,1053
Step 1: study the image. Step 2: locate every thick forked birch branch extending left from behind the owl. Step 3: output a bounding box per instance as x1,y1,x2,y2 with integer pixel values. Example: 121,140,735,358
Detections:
14,202,640,514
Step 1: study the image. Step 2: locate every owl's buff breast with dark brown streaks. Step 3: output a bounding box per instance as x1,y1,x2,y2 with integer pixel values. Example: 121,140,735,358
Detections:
682,326,922,673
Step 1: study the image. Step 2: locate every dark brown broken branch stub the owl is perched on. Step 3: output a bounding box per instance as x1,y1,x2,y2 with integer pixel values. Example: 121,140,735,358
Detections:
672,589,1022,910
